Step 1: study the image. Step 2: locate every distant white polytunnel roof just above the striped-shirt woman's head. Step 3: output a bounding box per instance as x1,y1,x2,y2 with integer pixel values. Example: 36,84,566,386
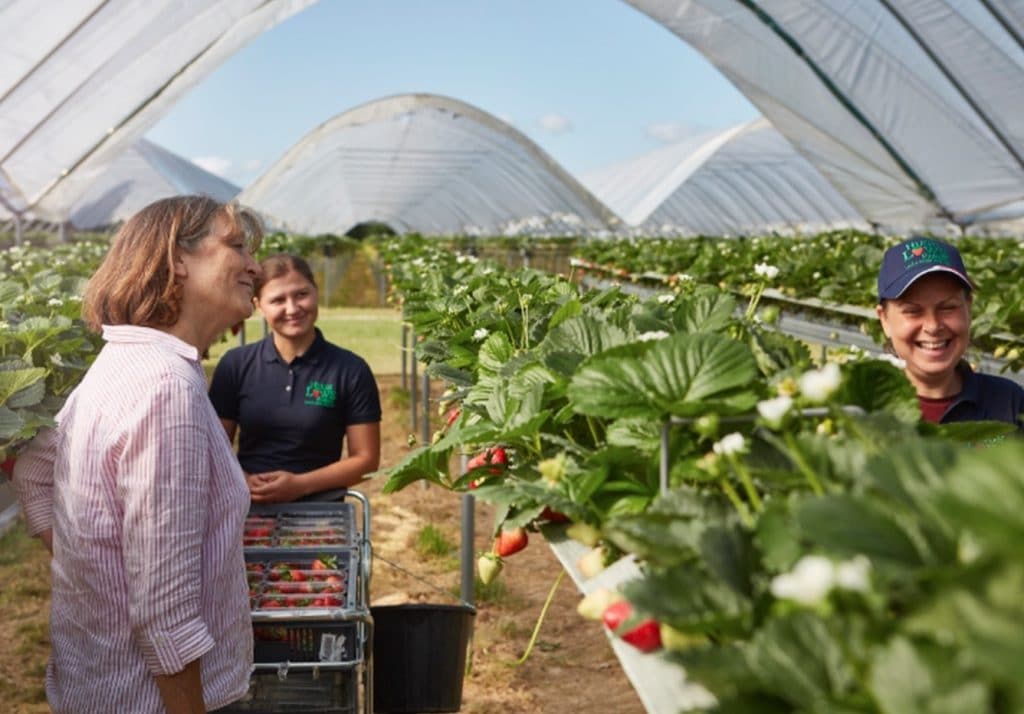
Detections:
70,139,242,228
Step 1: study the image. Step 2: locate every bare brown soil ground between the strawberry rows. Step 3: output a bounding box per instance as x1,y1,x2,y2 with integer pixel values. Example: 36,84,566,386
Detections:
0,376,644,714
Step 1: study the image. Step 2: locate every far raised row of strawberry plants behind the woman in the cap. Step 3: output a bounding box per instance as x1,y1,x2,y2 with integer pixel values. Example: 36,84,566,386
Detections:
574,229,1024,370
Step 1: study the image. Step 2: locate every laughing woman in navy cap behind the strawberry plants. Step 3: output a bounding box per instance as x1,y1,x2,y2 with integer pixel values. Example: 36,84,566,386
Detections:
876,238,1024,429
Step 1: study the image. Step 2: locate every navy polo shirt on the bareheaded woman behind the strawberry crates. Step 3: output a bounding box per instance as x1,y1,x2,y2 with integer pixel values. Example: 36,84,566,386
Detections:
210,329,381,473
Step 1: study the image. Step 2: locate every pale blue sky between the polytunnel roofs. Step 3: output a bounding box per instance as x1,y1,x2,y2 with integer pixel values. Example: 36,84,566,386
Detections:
147,0,758,185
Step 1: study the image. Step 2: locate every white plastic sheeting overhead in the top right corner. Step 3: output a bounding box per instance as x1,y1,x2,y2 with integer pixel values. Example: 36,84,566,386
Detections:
627,0,1024,229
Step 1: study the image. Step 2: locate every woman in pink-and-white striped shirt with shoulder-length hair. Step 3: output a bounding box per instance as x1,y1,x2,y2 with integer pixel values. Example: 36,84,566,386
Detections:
14,196,262,714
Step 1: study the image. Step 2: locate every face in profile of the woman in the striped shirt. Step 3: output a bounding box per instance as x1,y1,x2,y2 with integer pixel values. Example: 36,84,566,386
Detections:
176,215,260,334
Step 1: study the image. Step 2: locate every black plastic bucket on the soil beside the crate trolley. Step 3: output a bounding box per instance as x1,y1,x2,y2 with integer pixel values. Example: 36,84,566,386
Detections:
370,603,476,714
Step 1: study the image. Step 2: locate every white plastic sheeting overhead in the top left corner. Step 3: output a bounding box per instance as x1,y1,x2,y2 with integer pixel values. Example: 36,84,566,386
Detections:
0,0,314,220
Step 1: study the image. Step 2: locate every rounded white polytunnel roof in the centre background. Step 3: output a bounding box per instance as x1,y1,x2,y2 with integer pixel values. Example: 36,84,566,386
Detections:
239,94,618,235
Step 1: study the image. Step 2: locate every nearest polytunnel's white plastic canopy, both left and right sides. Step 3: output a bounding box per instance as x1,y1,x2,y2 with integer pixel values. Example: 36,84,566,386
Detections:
0,0,1024,236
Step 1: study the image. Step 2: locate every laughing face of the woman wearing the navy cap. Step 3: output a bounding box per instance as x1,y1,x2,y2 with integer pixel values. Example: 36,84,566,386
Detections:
876,272,971,396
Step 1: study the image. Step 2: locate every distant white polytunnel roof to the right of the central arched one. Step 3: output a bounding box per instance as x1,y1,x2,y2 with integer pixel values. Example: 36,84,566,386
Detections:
582,119,867,236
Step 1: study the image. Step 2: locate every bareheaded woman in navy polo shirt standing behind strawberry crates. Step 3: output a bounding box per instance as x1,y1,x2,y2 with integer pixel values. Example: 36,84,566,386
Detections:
210,254,381,503
